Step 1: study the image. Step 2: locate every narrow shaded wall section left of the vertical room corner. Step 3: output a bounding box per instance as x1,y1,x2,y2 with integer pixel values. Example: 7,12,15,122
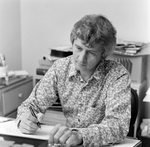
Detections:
0,0,22,70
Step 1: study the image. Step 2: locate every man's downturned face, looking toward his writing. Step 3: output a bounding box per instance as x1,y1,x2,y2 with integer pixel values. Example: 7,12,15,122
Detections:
73,38,102,72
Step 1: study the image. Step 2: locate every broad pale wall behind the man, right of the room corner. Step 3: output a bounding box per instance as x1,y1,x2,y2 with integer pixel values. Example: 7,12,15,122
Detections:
21,0,150,85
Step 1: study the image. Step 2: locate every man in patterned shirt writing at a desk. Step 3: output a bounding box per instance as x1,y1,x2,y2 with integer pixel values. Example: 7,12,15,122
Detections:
17,15,131,147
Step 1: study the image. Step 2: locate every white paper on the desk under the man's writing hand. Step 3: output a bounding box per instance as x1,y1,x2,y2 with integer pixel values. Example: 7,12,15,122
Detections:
0,121,53,140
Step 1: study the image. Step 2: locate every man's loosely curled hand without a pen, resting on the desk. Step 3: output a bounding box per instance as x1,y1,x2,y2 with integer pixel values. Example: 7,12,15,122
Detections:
49,124,83,147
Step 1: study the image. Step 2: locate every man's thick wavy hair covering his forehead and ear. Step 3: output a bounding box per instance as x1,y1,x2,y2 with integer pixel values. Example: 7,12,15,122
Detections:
70,14,116,58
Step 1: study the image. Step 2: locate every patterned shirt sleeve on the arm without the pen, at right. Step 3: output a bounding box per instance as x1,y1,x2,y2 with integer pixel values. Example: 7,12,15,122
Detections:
76,74,131,147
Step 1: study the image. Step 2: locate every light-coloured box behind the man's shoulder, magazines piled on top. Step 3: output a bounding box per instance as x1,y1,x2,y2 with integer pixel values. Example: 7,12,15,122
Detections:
108,54,147,83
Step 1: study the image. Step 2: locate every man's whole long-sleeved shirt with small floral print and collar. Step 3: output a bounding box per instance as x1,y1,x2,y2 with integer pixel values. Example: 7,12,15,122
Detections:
18,56,131,147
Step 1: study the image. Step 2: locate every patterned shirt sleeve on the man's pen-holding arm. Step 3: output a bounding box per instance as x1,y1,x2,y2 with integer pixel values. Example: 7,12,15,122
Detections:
16,64,58,120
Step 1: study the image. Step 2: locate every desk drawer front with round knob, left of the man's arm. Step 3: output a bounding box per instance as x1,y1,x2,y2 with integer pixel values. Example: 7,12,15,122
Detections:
2,82,33,116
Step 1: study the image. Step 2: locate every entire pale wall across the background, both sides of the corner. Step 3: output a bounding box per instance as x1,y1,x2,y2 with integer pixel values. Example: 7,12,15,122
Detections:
0,0,150,86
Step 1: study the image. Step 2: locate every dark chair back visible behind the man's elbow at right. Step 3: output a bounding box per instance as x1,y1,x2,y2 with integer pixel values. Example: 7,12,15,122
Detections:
127,88,138,137
